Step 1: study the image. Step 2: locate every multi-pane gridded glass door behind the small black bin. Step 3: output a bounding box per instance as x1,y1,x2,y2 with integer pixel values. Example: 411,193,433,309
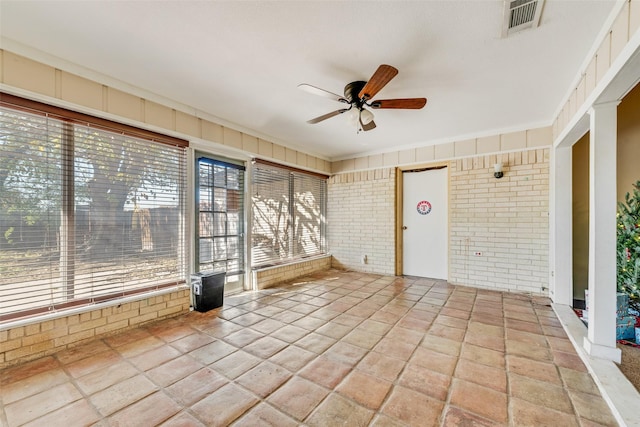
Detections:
196,157,245,291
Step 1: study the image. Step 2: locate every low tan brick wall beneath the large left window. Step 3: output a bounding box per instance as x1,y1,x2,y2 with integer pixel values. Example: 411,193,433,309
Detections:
0,288,191,369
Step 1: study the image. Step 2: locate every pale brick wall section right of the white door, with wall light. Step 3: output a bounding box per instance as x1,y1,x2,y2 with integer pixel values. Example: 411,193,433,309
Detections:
449,149,552,294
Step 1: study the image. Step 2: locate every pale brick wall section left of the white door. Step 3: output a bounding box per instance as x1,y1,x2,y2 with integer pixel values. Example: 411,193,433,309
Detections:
327,168,396,274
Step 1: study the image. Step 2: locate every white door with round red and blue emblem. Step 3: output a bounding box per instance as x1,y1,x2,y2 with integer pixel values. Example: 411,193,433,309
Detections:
402,168,449,280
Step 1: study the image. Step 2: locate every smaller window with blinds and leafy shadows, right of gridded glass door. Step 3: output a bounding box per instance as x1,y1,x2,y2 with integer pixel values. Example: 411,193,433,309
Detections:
251,161,327,267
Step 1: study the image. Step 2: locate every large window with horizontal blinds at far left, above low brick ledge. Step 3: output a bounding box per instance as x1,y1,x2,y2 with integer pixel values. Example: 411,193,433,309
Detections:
0,94,186,321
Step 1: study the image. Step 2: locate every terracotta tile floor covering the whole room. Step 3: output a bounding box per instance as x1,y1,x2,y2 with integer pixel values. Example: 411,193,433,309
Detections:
0,270,616,427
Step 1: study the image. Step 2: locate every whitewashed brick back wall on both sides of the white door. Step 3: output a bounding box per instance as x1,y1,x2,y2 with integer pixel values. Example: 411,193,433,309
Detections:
327,148,549,294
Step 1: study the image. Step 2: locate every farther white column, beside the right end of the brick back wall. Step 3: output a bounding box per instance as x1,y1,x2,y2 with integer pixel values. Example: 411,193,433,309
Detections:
549,146,573,306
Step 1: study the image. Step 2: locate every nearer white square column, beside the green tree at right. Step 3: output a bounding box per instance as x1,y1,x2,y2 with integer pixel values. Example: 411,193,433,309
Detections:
584,102,621,363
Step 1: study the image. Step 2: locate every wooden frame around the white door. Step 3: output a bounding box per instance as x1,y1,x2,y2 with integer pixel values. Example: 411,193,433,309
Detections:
395,161,451,277
